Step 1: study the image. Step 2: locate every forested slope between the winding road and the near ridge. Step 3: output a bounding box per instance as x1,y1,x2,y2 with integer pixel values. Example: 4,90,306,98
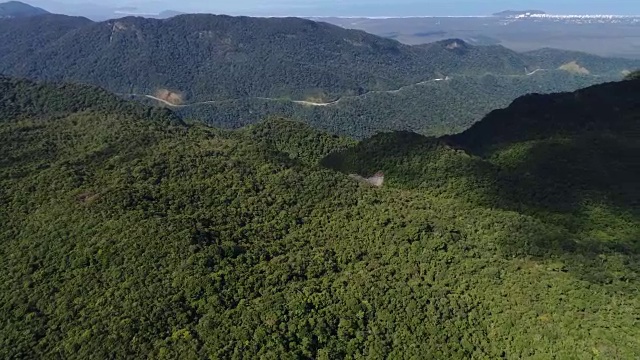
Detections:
170,72,592,139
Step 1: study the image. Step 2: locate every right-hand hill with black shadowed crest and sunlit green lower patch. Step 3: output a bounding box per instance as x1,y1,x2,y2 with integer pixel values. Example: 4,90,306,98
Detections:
323,80,640,222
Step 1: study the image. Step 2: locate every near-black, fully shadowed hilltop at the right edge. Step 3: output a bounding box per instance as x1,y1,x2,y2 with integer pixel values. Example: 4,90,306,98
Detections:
450,80,640,153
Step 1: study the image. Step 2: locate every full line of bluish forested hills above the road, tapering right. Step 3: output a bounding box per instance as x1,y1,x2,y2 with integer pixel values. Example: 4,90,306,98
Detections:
0,15,640,102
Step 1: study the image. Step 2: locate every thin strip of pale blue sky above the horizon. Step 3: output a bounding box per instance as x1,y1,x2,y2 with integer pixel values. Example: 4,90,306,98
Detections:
28,0,640,16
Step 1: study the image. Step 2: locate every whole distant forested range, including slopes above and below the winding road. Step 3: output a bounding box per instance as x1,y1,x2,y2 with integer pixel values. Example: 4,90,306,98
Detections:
0,14,640,138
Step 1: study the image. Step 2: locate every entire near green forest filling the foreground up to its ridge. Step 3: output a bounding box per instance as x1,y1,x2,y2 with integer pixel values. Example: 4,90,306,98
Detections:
0,78,640,359
